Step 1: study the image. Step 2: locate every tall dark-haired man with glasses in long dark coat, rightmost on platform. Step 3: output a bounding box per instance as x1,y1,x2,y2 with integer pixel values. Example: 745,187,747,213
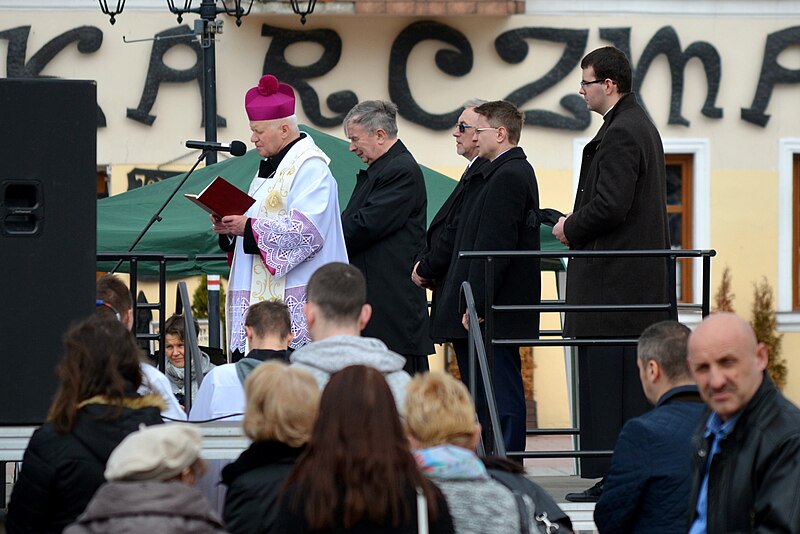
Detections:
553,46,672,502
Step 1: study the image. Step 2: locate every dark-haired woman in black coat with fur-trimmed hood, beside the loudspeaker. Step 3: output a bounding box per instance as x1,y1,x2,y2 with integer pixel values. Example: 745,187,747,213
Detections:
6,314,164,534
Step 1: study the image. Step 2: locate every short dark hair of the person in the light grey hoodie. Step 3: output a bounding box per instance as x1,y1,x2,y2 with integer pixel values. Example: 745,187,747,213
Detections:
306,262,367,323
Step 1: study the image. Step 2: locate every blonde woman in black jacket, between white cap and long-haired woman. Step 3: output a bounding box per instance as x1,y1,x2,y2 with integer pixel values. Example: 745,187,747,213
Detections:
222,360,320,534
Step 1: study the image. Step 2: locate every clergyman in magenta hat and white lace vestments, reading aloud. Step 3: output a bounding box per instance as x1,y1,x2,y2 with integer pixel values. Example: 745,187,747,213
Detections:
211,75,347,360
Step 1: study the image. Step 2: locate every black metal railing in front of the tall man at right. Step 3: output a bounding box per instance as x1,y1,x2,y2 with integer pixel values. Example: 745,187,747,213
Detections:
459,250,716,458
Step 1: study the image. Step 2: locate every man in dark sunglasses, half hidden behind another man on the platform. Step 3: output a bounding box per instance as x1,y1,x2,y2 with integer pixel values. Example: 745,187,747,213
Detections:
411,98,487,381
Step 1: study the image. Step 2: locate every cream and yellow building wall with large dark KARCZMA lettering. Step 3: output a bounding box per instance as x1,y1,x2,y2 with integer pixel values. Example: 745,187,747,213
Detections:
0,0,800,426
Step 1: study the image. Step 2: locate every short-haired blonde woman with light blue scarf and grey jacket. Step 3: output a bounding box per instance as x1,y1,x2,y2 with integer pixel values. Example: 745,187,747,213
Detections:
405,373,572,534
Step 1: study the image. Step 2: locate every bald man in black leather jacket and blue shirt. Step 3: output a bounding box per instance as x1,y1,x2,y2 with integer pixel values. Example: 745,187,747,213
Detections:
687,313,800,534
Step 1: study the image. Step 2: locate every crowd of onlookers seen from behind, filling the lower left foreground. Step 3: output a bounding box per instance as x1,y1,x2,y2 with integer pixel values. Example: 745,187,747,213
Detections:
6,262,571,534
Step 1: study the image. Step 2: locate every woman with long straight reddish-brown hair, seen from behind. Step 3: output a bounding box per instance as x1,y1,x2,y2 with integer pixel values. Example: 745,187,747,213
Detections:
276,365,453,534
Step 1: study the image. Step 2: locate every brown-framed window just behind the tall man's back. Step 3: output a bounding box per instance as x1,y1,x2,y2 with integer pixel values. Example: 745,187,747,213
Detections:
665,154,694,302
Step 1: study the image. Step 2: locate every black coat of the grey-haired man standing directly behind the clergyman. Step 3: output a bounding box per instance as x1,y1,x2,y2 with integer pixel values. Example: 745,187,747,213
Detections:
342,139,433,355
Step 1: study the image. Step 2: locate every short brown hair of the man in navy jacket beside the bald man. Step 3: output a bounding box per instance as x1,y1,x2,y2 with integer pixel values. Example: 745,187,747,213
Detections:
636,321,691,381
